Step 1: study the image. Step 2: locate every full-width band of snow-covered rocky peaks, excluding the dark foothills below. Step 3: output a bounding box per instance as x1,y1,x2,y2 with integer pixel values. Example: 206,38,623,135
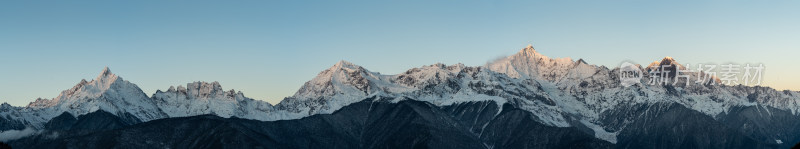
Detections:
0,46,800,143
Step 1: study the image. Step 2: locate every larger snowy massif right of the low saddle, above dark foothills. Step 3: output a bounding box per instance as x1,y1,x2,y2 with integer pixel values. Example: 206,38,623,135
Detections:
277,46,800,142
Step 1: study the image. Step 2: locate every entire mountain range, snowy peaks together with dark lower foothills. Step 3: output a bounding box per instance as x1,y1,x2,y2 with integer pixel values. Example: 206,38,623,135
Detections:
0,46,800,149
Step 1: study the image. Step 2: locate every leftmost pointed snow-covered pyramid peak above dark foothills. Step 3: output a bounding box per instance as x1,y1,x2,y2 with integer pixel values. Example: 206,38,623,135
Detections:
19,67,165,126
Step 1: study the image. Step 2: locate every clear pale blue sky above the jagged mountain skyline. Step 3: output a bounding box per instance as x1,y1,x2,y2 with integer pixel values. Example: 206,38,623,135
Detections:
0,0,800,106
